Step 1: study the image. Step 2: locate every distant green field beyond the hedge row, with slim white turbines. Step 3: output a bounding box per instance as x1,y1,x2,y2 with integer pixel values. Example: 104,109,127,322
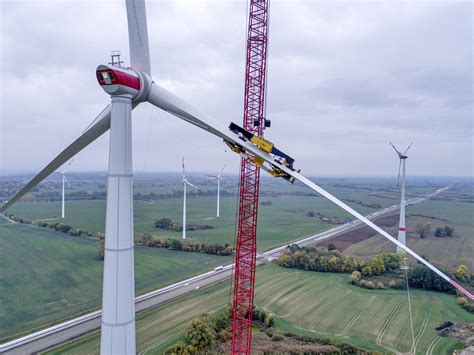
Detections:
9,196,374,250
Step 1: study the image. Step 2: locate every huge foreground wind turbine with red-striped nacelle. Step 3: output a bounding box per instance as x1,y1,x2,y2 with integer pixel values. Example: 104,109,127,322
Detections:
0,0,474,354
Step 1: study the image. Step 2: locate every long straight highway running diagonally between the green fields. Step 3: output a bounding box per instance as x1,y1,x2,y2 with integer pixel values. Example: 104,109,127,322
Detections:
0,187,449,354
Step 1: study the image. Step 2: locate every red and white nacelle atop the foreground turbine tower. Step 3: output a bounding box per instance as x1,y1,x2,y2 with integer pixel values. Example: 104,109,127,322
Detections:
96,64,152,102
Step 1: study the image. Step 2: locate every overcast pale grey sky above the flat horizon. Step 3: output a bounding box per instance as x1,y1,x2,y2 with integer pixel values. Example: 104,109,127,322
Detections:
0,0,474,176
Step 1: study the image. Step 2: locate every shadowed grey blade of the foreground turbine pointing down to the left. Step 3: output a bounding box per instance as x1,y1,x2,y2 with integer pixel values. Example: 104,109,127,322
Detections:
0,105,110,213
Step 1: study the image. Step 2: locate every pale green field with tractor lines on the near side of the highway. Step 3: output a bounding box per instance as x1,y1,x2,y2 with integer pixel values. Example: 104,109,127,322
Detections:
45,265,474,354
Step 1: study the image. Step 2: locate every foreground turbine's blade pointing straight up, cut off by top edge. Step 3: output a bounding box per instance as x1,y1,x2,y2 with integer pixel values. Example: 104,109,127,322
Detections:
126,0,151,75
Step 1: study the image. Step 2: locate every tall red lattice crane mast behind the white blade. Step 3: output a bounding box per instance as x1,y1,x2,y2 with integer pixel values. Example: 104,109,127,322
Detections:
232,0,269,354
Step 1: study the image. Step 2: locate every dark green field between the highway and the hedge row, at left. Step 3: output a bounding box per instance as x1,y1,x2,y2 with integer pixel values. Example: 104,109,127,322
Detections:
0,224,231,340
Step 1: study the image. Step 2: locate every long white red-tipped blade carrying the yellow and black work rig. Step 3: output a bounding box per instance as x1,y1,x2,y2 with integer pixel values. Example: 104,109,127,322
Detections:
147,83,474,299
